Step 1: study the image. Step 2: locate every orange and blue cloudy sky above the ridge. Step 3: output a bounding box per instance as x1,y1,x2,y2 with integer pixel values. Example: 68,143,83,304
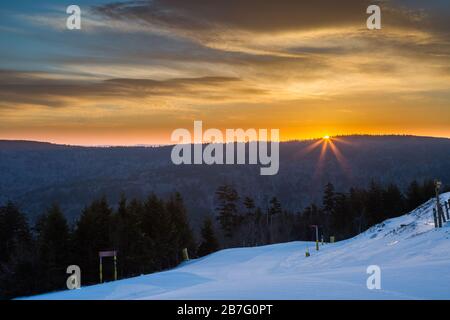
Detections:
0,0,450,145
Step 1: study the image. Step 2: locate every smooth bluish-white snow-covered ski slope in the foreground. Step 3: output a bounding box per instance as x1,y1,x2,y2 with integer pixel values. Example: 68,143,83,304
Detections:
23,193,450,299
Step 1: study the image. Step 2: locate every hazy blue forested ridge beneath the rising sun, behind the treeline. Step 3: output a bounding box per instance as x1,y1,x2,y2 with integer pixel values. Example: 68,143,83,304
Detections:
0,136,450,228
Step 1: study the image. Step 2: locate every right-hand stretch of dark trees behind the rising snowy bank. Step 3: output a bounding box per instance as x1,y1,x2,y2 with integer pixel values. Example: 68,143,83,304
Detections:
216,180,442,246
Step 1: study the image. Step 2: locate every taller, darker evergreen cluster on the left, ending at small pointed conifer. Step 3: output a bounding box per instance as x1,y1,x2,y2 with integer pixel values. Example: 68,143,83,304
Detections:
0,193,218,298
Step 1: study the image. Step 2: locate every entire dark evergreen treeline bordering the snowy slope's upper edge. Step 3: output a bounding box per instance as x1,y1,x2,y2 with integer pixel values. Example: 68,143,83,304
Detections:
0,181,442,298
